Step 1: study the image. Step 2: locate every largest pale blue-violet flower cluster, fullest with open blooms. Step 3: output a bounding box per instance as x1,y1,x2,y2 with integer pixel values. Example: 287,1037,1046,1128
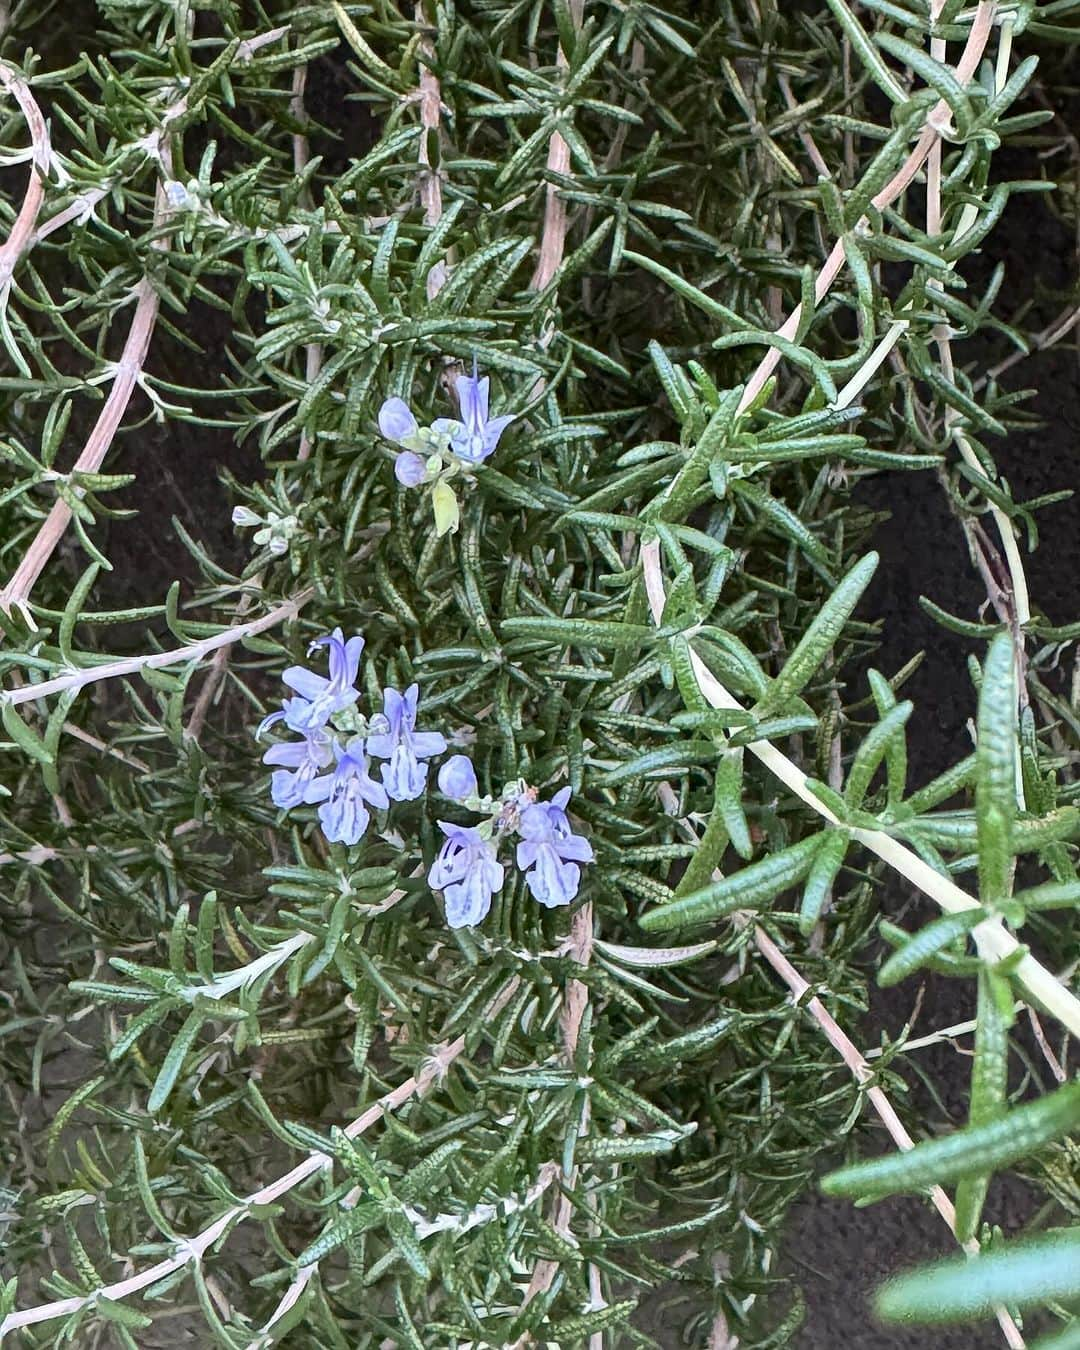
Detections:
257,628,447,844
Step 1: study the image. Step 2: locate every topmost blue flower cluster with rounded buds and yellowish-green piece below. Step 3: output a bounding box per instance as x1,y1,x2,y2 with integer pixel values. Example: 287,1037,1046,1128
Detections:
379,362,514,535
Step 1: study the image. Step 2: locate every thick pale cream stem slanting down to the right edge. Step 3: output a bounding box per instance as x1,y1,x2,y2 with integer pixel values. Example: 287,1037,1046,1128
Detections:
641,540,1080,1035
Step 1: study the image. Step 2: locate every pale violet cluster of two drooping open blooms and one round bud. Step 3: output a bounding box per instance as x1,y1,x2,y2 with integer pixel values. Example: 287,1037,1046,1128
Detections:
428,755,593,927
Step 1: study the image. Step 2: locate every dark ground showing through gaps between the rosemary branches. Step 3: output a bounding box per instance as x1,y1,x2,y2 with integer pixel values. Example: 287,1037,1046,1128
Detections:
37,49,1080,1350
